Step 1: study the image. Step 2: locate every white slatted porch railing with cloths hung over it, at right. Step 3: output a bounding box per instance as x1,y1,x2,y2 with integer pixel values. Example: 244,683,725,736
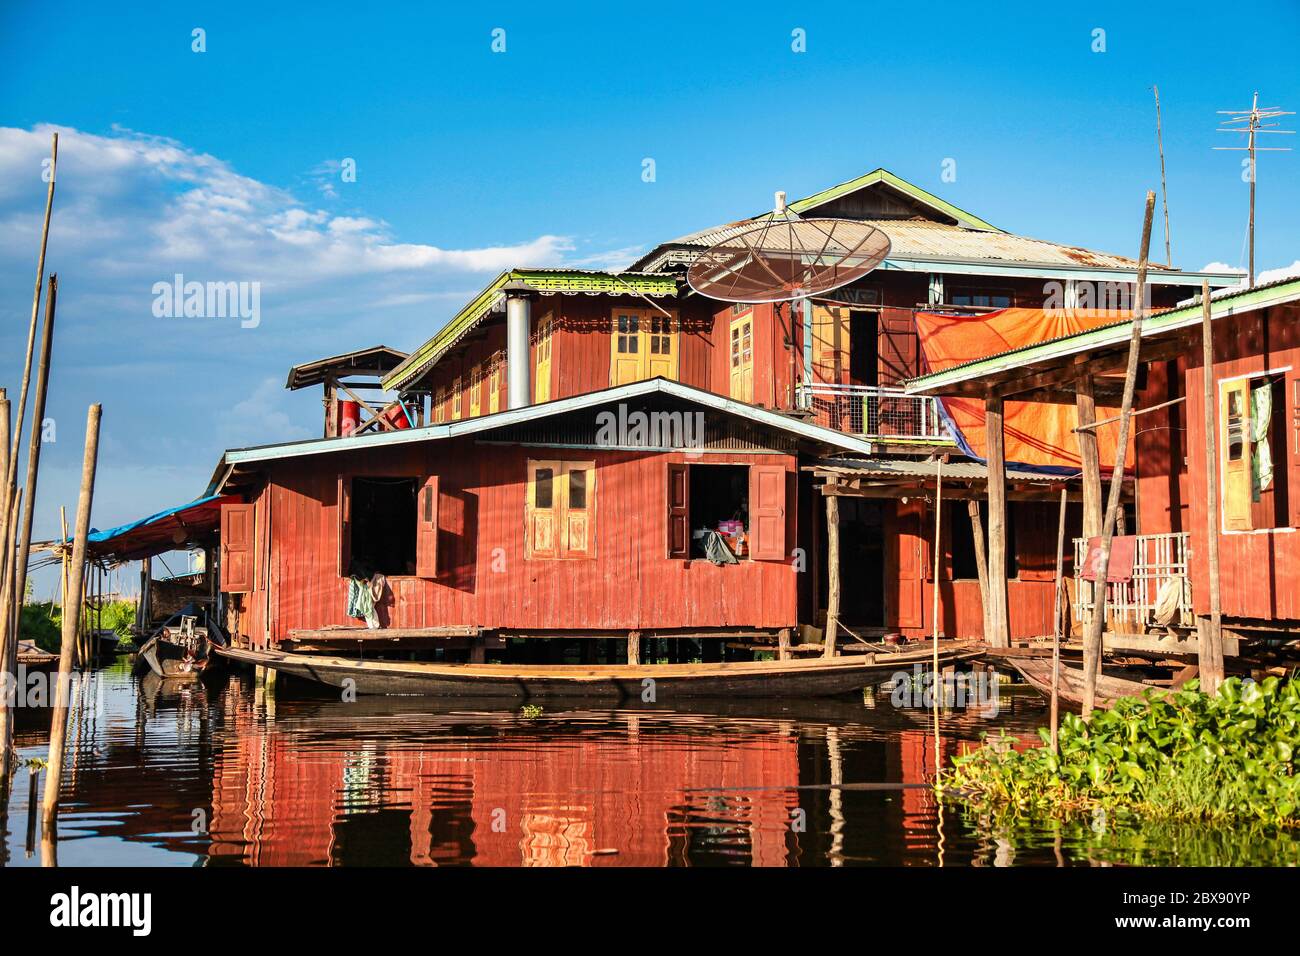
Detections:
1074,532,1196,633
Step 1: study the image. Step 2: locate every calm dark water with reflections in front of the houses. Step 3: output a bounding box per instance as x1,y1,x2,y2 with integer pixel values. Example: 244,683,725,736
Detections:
0,659,1300,866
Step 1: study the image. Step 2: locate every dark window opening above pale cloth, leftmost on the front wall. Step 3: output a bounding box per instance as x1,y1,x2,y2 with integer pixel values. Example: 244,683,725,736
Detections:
339,475,416,578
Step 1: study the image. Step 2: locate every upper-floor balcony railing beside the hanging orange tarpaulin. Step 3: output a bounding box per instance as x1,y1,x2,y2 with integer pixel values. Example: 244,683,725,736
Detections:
798,385,953,444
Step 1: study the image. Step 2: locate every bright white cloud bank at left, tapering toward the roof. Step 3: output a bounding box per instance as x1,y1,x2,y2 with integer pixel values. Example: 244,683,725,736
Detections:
0,126,573,287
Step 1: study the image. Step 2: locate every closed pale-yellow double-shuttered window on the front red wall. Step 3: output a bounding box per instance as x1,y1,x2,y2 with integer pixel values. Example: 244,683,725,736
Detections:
525,459,595,558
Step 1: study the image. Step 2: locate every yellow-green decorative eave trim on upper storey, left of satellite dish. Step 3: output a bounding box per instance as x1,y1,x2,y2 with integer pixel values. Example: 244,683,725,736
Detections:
382,268,677,389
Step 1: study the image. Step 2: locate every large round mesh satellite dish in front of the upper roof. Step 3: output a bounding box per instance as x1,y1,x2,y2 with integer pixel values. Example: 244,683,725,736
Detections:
686,193,889,302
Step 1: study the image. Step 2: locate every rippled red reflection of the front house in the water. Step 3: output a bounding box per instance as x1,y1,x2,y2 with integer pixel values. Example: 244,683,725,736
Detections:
208,671,982,866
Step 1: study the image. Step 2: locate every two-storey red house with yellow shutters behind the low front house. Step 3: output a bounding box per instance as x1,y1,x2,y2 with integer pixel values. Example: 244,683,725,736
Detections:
343,170,1235,647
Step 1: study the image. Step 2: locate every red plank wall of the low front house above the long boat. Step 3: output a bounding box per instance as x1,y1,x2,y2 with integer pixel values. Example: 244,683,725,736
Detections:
241,440,797,645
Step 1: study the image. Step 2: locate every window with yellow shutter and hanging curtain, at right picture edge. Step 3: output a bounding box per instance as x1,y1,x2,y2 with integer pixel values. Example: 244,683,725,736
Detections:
1219,375,1291,531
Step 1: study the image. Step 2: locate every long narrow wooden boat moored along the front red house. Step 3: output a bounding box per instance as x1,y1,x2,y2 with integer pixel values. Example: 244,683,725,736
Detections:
213,645,979,701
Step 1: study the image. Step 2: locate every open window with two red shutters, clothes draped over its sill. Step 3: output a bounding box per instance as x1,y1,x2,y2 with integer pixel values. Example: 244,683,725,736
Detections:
667,463,787,561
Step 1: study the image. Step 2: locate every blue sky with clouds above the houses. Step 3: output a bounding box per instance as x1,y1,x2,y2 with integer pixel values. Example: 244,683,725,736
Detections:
0,0,1300,595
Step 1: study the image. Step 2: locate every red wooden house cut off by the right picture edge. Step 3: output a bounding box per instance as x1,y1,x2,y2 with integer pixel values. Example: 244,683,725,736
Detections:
914,278,1300,658
